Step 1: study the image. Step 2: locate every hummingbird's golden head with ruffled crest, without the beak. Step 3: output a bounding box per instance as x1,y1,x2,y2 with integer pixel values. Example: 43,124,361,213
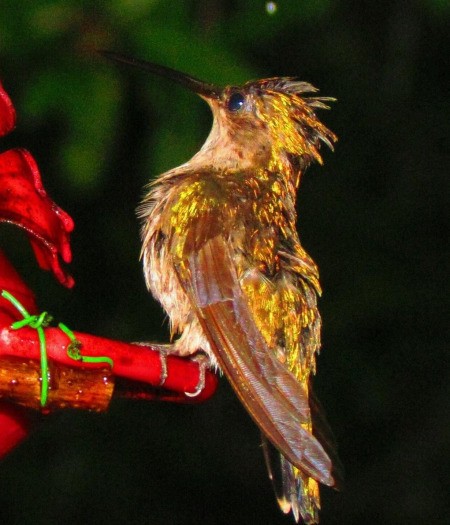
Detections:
201,78,336,170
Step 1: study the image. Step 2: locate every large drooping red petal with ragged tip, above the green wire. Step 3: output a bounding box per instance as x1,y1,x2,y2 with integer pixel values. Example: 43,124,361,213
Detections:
0,149,74,288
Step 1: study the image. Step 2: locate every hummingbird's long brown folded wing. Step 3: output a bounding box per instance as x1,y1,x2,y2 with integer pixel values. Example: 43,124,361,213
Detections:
175,234,335,486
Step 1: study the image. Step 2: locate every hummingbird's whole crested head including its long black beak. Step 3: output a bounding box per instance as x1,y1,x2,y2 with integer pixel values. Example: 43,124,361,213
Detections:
101,51,337,176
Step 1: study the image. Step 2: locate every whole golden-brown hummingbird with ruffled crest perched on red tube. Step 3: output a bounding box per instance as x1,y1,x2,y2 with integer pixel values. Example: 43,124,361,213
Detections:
102,51,341,524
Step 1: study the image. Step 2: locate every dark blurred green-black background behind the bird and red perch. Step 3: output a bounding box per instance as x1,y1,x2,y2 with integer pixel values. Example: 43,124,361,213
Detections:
0,0,450,525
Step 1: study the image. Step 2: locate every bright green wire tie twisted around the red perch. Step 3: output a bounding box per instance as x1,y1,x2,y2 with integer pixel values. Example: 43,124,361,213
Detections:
1,290,114,407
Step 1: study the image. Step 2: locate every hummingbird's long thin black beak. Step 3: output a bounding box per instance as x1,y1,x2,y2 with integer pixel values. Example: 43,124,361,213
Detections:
99,50,222,98
